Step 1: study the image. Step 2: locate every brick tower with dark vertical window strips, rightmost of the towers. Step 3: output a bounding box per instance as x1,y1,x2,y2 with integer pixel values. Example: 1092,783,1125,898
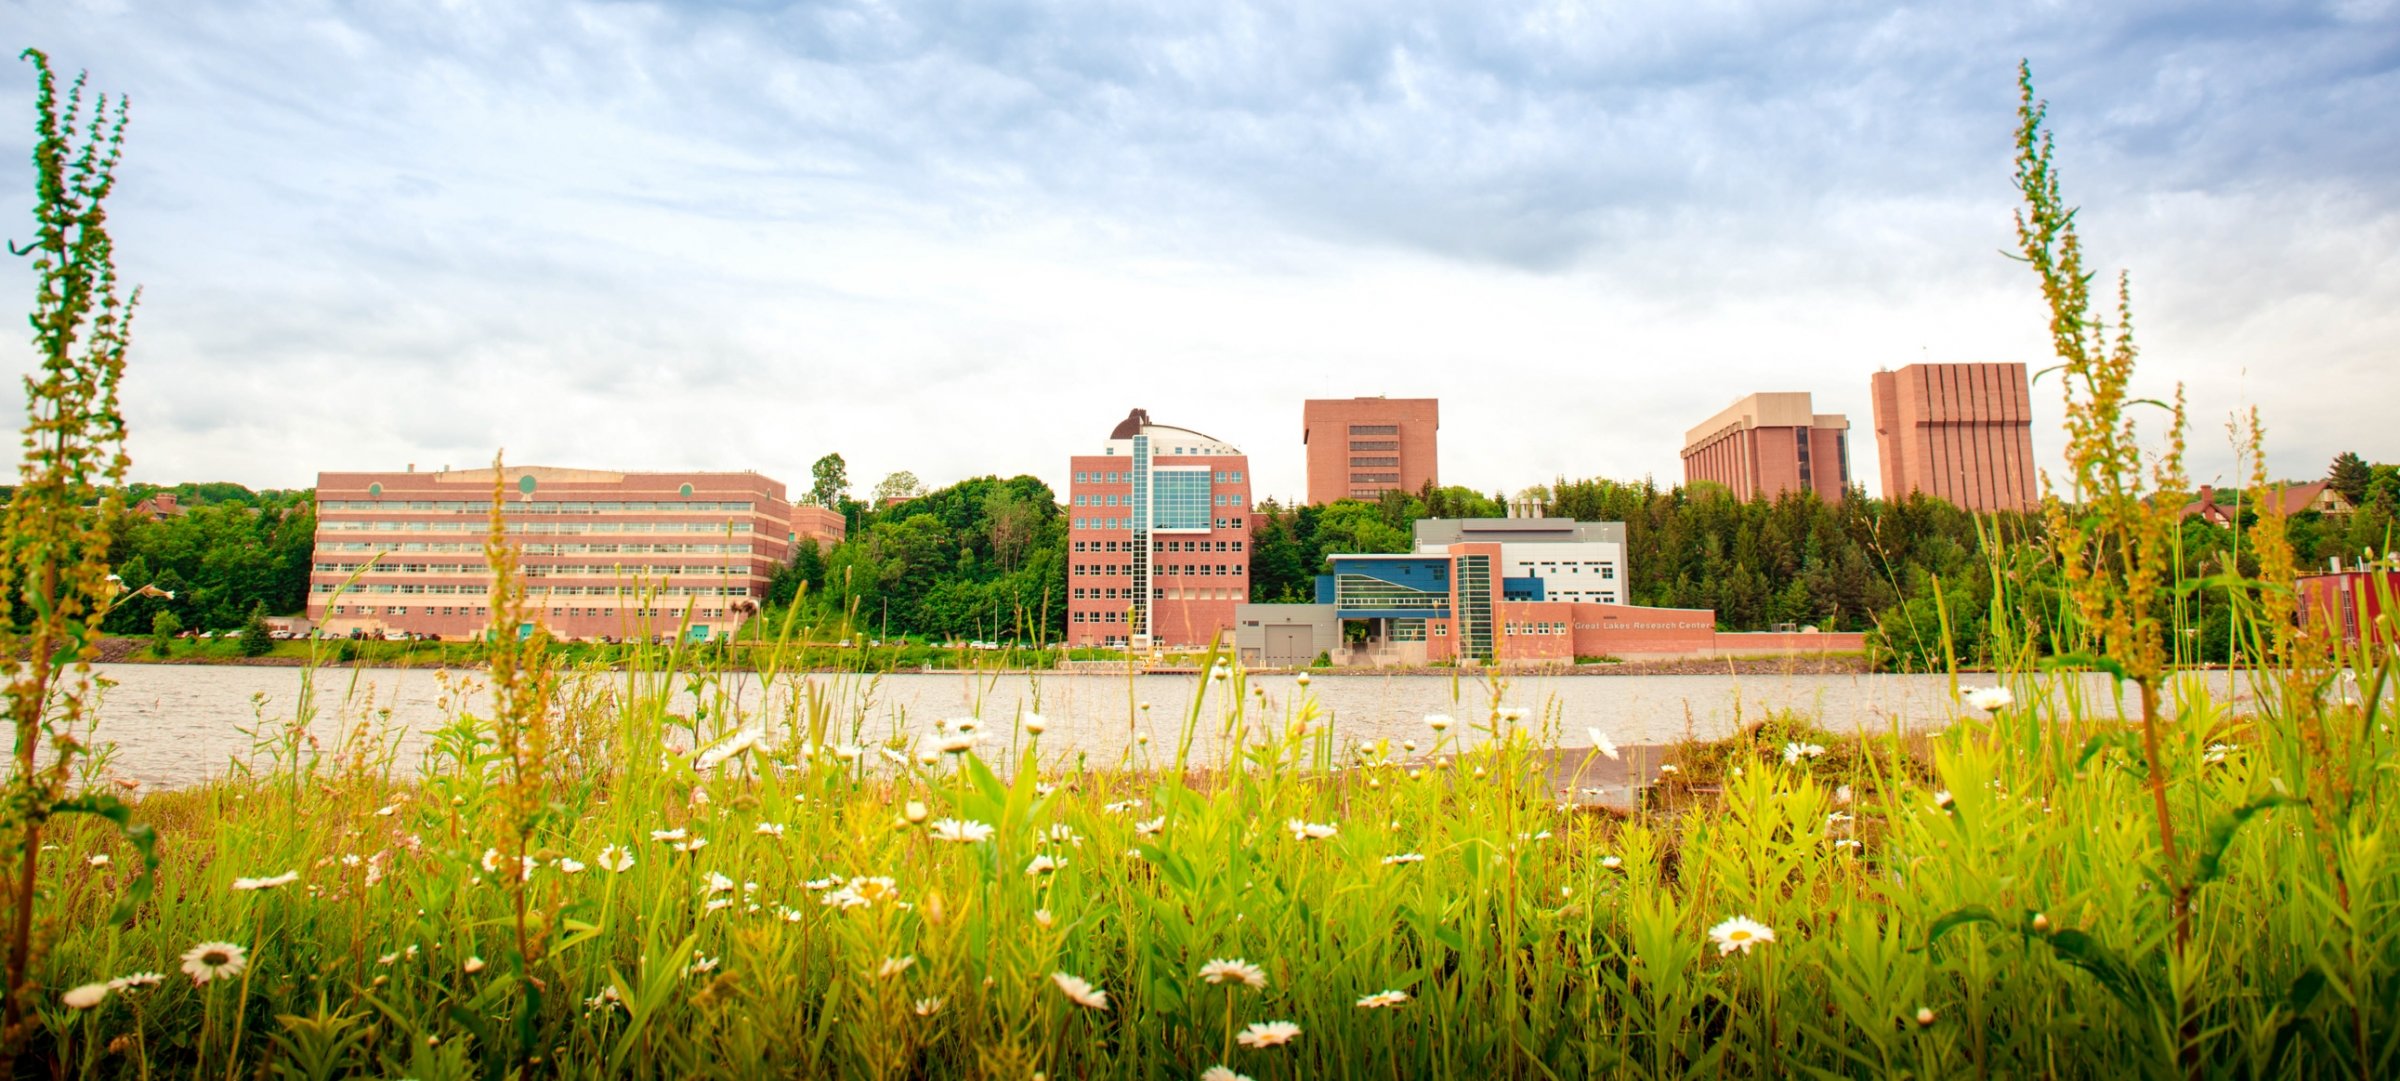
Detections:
1874,365,2040,512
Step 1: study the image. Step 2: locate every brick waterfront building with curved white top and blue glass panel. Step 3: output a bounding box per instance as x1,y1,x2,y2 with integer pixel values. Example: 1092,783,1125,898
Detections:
1066,408,1250,649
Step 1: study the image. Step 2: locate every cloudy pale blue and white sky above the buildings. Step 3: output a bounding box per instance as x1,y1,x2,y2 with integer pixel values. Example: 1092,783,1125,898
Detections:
0,0,2400,500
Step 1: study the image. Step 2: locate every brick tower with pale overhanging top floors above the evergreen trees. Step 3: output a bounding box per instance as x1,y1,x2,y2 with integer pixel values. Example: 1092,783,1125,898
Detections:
1682,392,1850,502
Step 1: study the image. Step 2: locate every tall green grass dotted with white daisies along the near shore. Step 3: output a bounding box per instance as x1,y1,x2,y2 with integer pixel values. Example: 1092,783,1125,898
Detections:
22,59,2400,1079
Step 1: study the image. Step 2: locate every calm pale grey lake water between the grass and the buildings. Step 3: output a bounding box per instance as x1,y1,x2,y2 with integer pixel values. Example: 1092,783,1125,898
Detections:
65,665,2256,786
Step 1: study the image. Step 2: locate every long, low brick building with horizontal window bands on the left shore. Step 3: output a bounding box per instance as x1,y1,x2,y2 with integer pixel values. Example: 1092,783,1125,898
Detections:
307,466,842,641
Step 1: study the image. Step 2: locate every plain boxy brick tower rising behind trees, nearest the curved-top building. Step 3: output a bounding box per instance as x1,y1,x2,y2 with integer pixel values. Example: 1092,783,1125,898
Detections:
1301,396,1442,504
